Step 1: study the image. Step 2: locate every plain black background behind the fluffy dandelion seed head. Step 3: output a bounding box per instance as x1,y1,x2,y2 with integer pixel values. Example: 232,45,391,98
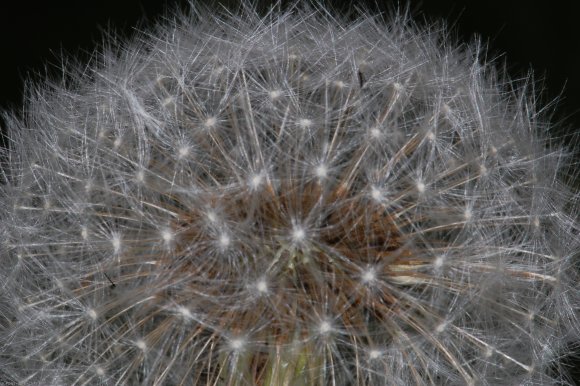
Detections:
0,0,580,384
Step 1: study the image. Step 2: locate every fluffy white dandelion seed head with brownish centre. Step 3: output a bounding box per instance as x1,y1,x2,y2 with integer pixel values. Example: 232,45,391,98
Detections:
0,3,580,386
